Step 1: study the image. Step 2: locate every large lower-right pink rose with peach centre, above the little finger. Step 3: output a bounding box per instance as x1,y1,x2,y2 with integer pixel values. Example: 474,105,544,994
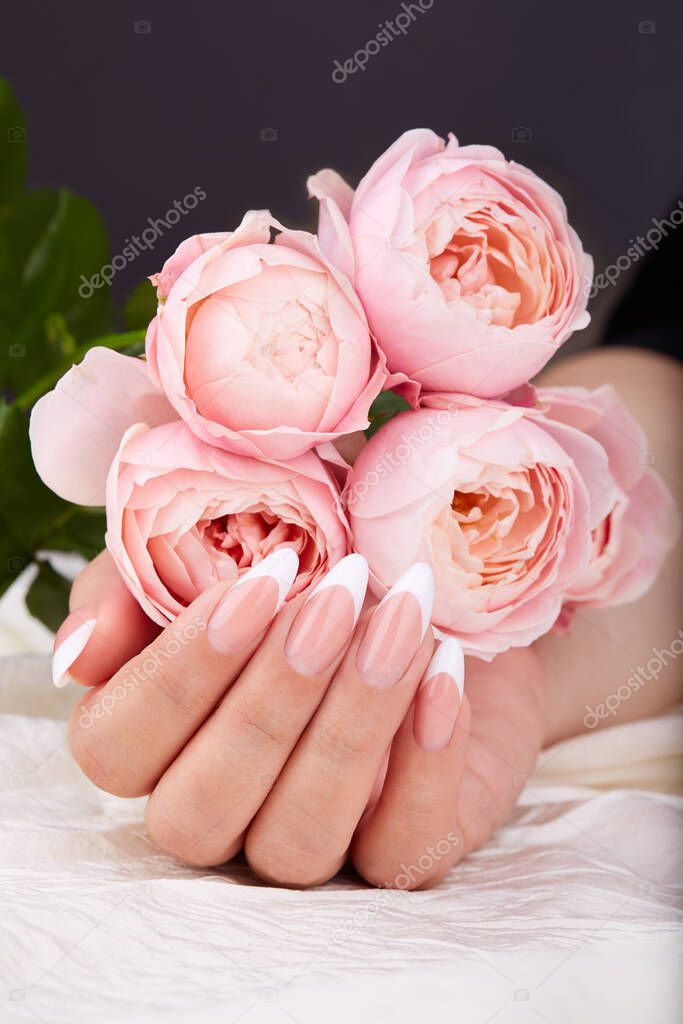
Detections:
346,394,616,659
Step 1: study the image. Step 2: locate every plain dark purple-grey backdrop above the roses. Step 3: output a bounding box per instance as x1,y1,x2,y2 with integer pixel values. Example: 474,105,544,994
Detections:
0,0,683,344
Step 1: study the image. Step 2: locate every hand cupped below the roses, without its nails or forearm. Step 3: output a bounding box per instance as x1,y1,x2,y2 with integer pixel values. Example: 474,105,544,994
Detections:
56,554,544,888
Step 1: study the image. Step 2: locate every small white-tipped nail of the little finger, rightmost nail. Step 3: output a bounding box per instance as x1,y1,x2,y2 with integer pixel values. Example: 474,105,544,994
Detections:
413,637,465,754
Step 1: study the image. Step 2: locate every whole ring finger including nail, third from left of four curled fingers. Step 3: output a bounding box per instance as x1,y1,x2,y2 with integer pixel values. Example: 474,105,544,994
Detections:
245,570,433,886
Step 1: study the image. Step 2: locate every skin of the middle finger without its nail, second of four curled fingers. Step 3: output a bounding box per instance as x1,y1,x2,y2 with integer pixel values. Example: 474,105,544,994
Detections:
145,597,358,867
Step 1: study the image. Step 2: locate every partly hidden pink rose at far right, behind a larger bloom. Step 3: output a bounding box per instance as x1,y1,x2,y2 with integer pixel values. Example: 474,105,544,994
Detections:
538,384,680,626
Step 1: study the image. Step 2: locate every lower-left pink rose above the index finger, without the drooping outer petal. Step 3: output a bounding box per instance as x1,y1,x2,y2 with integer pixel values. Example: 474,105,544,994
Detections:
106,421,350,626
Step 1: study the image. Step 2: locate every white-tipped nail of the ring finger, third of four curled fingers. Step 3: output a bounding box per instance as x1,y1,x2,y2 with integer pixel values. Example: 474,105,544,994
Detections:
355,562,434,689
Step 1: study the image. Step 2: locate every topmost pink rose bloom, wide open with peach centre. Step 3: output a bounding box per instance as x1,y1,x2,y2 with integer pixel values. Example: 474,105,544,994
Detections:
309,129,593,397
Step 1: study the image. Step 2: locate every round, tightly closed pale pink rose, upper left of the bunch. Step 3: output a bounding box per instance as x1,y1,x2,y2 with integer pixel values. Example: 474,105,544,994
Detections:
146,211,387,459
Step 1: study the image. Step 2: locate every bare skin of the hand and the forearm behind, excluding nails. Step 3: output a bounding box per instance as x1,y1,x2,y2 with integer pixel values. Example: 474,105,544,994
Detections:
57,350,683,889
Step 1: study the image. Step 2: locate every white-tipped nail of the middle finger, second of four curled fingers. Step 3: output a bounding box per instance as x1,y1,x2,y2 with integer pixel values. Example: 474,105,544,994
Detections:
285,554,368,676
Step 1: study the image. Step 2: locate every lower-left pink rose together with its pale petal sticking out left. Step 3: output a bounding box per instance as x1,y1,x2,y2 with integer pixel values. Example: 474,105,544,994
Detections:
31,348,350,625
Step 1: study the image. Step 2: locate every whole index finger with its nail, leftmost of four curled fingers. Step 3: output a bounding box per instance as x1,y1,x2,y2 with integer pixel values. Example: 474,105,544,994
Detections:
71,548,298,797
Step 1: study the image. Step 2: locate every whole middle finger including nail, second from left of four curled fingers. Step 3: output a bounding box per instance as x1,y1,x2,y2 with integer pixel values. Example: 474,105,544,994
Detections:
141,555,368,866
